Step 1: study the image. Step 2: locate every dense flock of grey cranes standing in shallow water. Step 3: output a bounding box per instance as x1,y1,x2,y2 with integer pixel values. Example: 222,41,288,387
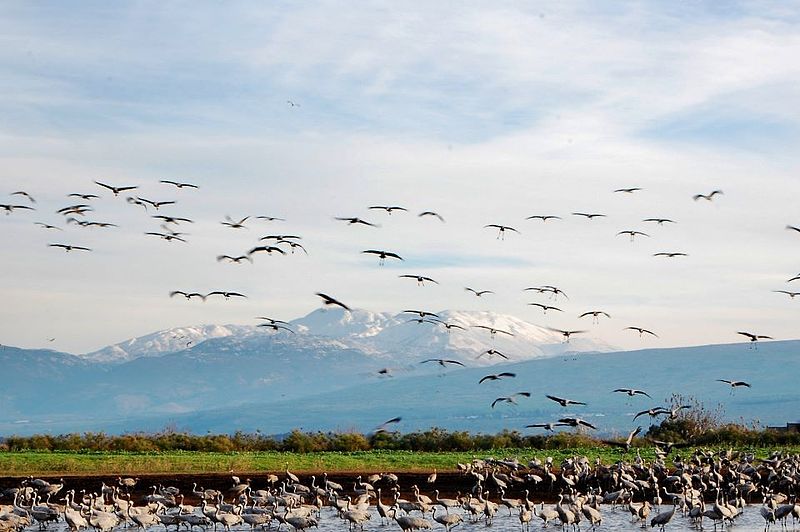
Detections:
0,448,800,532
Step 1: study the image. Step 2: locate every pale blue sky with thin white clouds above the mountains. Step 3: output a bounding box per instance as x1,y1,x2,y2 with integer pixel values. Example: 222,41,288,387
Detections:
0,1,800,353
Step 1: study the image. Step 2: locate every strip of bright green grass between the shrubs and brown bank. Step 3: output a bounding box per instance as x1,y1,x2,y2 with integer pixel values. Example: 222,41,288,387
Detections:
0,447,800,476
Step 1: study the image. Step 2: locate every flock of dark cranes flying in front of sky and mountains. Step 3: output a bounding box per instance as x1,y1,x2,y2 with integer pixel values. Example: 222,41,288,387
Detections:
0,180,800,439
